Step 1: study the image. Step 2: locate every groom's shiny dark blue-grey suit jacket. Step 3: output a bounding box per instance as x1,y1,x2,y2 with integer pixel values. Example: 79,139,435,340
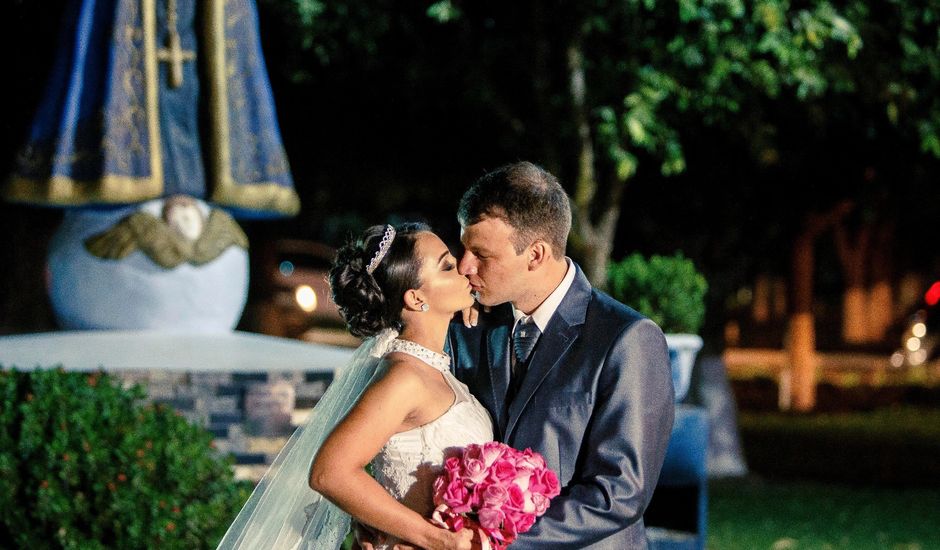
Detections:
448,264,674,550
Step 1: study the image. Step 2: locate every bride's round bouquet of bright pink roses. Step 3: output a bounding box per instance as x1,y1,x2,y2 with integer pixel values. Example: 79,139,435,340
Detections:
431,441,560,550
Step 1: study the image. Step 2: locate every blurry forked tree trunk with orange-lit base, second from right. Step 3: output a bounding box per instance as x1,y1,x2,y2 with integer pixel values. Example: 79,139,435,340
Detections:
835,224,871,344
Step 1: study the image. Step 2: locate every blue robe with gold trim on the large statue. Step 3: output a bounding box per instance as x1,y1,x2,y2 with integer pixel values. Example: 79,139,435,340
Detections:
4,0,299,217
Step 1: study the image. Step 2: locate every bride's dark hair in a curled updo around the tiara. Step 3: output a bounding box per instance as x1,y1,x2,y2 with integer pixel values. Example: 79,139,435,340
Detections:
330,223,431,338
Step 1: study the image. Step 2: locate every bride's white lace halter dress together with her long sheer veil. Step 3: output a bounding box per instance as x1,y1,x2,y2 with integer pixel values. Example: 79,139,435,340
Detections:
218,331,493,550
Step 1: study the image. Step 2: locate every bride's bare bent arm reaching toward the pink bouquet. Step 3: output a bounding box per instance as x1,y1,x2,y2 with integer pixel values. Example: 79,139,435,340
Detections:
310,363,470,549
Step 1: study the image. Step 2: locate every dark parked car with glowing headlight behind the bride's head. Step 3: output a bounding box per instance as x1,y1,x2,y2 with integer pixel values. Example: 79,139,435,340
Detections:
257,239,343,338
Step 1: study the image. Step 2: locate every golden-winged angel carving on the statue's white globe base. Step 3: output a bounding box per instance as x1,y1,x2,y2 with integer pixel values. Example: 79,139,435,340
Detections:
85,195,248,269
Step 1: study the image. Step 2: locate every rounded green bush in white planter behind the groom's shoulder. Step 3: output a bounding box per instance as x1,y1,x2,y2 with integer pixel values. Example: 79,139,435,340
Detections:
607,253,708,334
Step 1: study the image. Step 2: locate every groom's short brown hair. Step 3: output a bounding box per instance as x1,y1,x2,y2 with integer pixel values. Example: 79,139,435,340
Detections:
457,162,571,259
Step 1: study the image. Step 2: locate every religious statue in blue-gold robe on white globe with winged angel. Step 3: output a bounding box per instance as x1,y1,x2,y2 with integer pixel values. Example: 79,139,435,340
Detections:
3,0,300,330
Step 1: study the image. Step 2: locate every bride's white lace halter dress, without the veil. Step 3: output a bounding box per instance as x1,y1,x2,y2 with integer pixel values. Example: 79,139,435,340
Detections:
372,340,493,550
